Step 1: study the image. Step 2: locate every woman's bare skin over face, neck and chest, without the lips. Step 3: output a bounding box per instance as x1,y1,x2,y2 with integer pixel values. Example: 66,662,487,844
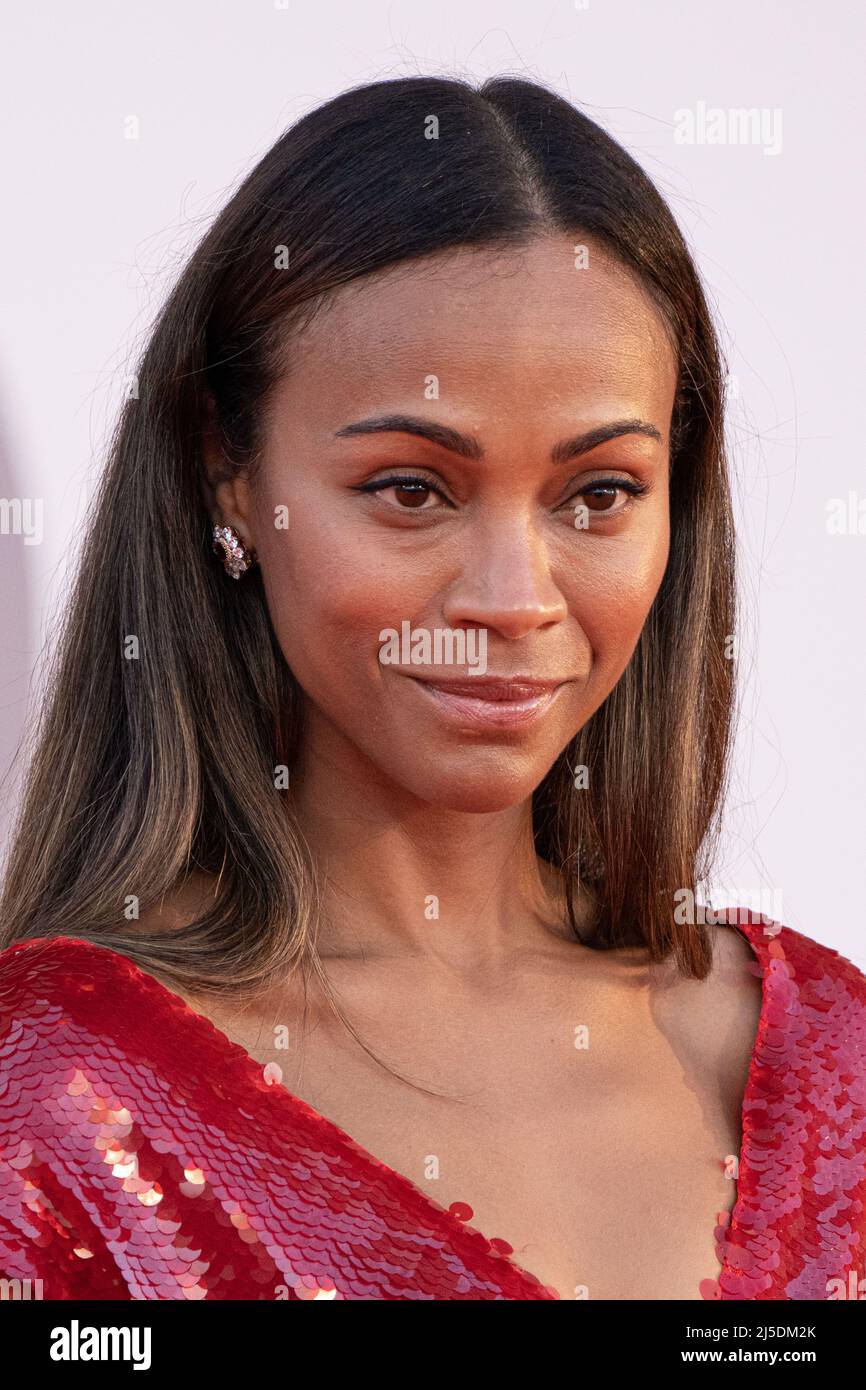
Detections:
148,235,760,1300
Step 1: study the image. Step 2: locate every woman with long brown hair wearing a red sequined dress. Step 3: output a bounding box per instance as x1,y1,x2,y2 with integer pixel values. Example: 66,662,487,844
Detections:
0,78,866,1300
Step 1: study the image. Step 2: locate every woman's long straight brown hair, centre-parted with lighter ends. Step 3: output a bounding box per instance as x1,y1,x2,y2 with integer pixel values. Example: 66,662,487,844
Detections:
0,76,735,994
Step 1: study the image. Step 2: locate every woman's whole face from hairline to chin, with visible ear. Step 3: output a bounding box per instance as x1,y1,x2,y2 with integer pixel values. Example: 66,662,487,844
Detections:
217,236,676,810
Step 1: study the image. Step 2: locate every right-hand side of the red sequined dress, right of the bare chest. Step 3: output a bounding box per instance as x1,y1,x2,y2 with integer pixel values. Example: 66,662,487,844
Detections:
701,913,866,1300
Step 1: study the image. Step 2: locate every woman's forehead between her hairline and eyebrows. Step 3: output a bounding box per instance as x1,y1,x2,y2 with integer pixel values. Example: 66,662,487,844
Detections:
274,235,677,428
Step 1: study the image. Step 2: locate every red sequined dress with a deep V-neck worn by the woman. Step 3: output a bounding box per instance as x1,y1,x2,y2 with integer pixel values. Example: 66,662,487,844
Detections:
0,909,866,1300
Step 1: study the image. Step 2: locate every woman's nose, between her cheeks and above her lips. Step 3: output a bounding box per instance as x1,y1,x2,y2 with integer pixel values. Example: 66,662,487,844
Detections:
442,513,569,638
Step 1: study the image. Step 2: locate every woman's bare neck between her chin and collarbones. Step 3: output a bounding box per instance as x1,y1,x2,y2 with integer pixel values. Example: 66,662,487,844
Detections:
292,706,583,973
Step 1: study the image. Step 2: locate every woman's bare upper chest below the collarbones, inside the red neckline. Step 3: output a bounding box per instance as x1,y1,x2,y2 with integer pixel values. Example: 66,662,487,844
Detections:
211,984,741,1300
